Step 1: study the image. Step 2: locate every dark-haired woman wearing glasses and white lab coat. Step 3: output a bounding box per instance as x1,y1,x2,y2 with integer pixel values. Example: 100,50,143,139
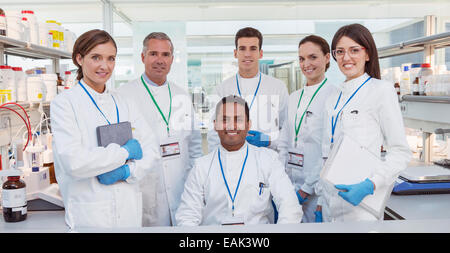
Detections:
319,24,411,221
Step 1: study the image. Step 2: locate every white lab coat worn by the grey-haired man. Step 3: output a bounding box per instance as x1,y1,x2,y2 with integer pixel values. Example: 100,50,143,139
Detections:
118,78,202,226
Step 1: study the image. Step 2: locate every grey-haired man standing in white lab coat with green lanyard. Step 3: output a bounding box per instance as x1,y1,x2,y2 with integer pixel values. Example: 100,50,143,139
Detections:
119,32,202,226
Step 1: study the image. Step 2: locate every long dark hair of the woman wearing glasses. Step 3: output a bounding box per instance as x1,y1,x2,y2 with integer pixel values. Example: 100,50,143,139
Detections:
331,24,381,79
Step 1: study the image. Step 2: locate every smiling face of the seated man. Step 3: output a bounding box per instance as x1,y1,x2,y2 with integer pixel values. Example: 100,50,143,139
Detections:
214,103,251,151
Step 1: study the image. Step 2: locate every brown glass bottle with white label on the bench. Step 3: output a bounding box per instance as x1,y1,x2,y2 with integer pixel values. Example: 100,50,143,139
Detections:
2,176,27,222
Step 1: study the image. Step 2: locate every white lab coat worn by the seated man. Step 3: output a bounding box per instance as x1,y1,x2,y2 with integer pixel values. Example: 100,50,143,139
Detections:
176,142,302,226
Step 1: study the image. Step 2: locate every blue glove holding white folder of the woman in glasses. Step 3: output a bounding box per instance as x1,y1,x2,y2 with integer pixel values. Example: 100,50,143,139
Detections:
334,178,374,206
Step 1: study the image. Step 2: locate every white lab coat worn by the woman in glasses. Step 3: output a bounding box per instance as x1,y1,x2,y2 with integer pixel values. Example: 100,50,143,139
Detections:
319,73,411,221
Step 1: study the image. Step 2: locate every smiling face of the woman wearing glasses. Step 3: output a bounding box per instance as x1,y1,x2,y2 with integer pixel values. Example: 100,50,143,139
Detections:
336,36,369,81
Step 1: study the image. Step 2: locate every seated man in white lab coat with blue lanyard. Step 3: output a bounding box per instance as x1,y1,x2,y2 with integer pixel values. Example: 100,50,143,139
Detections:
175,95,303,226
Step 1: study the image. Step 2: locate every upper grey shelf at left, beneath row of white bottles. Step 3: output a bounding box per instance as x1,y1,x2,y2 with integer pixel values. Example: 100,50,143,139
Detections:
0,36,72,59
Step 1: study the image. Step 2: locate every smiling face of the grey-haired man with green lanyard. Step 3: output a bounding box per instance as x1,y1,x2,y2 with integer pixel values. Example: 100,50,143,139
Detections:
141,39,173,85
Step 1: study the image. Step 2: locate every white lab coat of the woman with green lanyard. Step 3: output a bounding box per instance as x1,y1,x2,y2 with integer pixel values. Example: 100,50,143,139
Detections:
279,80,338,222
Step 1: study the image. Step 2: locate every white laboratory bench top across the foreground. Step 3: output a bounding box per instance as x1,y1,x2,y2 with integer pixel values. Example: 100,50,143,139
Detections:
0,211,450,233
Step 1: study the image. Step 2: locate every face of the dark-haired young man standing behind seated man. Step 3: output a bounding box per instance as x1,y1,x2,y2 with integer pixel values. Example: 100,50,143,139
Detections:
234,37,263,78
